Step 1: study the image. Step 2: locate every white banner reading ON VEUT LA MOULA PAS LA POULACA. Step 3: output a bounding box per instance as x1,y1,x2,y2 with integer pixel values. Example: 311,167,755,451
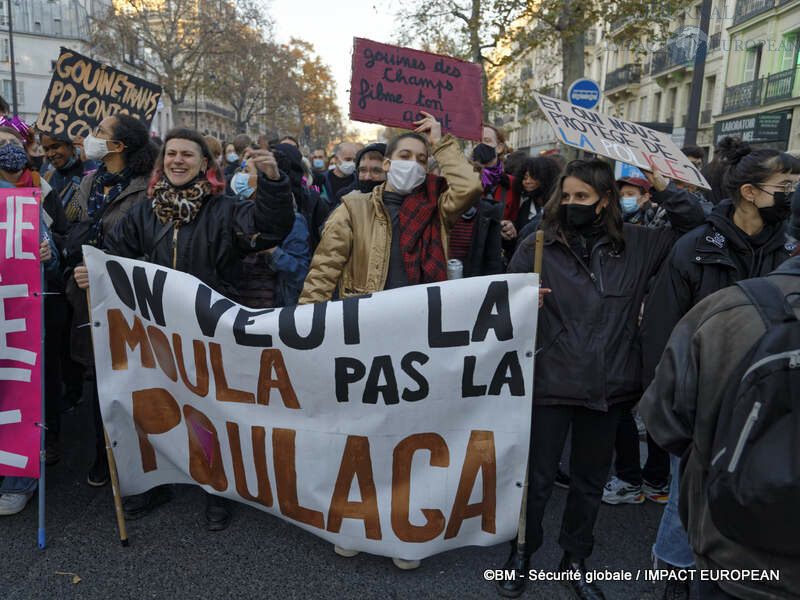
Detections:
84,247,538,559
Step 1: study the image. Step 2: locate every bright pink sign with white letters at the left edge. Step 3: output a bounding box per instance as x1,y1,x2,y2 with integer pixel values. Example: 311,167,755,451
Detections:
0,188,42,477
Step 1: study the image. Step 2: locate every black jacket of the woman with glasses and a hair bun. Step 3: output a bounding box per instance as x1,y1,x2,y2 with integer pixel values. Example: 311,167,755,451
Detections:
641,200,794,387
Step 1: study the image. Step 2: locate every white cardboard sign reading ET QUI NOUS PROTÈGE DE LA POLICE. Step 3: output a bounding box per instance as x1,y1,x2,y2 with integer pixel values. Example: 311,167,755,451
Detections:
535,94,711,189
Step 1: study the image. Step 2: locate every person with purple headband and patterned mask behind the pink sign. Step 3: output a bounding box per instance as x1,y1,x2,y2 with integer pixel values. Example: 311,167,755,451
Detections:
0,118,68,466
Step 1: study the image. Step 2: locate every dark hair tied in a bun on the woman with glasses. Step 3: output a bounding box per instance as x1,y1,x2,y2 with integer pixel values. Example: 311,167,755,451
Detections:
720,144,800,206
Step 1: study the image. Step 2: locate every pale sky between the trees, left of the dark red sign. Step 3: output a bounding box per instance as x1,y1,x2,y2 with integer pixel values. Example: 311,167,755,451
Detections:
269,0,394,135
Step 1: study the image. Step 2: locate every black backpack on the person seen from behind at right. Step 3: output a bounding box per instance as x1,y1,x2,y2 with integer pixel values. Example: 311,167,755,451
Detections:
707,278,800,556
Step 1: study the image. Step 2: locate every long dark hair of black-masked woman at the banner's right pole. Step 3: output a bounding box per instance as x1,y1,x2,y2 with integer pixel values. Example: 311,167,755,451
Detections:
542,159,625,252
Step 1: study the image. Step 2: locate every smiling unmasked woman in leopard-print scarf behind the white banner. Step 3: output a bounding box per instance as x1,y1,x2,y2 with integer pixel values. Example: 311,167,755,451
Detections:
74,127,294,531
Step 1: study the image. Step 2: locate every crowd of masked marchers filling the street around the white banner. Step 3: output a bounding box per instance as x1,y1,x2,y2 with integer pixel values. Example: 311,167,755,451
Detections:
0,90,800,600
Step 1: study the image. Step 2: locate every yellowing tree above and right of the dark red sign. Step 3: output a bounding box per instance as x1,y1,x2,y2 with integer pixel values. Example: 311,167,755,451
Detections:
397,0,692,116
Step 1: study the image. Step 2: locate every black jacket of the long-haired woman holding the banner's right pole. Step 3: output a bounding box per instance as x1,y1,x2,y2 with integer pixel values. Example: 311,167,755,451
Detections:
508,184,703,412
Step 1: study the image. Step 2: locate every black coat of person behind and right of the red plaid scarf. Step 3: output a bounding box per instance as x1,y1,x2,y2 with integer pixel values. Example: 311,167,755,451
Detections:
461,197,503,277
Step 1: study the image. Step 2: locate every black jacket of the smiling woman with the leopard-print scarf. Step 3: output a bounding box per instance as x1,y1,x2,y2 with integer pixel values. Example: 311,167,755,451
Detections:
104,173,294,298
